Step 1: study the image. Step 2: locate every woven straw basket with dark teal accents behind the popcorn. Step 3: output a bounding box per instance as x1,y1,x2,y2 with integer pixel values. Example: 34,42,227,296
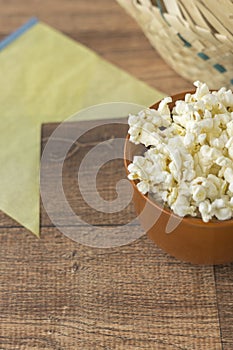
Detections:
117,0,233,89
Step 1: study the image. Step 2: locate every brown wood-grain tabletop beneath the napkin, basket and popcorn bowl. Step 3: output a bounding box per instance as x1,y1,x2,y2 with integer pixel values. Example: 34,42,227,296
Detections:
0,0,233,350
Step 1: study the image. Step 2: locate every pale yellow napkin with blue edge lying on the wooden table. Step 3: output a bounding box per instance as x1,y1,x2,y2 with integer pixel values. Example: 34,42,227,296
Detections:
0,20,162,235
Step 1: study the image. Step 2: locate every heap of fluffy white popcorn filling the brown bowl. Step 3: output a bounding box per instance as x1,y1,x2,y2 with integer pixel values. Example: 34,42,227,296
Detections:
128,81,233,222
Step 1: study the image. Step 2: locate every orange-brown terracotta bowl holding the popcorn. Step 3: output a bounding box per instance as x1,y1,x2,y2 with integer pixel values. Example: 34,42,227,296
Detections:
124,91,233,265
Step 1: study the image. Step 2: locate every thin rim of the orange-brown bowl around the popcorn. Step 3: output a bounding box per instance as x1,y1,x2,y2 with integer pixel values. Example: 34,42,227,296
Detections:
124,90,233,227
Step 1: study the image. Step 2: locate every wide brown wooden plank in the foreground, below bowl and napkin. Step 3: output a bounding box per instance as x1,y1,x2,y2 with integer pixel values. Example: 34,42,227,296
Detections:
0,228,221,350
